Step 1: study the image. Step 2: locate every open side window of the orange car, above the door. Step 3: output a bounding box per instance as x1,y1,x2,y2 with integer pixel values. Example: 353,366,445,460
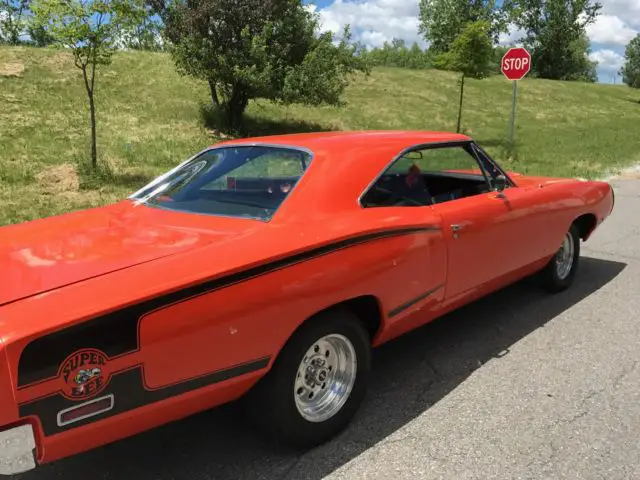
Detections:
361,145,490,207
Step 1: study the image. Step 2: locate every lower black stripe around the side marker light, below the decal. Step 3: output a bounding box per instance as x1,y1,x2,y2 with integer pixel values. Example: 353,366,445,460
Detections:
19,357,271,436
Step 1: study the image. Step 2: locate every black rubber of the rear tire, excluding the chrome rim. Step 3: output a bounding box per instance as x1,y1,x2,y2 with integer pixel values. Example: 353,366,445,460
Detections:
244,309,371,450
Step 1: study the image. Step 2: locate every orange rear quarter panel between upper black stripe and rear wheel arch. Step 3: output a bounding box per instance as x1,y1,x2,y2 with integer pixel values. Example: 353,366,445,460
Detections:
140,227,445,389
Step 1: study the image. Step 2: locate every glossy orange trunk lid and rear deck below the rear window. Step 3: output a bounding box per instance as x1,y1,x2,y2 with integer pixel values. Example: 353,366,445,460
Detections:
0,200,259,305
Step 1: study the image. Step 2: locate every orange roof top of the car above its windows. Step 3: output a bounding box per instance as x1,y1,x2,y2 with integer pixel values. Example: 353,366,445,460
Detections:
216,130,471,152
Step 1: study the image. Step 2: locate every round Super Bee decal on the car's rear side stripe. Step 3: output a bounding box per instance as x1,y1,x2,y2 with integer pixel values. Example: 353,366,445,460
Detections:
58,348,109,400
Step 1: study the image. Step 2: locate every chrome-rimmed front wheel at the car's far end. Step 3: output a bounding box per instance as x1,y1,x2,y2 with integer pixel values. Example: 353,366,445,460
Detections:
540,224,580,292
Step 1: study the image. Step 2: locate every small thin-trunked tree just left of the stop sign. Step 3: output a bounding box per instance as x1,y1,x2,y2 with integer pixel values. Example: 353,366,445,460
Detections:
436,20,493,132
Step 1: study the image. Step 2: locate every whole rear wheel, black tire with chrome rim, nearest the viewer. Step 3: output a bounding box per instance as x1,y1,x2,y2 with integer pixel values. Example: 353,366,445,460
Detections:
246,310,371,449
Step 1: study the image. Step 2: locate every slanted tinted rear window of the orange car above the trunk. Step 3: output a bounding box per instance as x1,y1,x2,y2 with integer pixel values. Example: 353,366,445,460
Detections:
131,146,312,221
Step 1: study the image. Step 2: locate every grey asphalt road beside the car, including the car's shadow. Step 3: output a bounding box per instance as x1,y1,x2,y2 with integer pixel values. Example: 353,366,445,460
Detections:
15,180,640,480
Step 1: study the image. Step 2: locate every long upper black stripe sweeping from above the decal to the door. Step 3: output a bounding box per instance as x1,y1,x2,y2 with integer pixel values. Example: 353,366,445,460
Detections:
18,226,440,388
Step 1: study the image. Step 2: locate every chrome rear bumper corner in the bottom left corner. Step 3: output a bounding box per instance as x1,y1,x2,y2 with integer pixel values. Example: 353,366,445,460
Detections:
0,425,36,475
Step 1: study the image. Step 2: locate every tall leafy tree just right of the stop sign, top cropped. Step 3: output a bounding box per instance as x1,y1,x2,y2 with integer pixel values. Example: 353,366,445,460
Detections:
505,0,601,81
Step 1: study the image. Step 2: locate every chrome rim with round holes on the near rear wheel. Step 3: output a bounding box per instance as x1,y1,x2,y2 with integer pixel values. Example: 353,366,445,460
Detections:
293,334,357,422
